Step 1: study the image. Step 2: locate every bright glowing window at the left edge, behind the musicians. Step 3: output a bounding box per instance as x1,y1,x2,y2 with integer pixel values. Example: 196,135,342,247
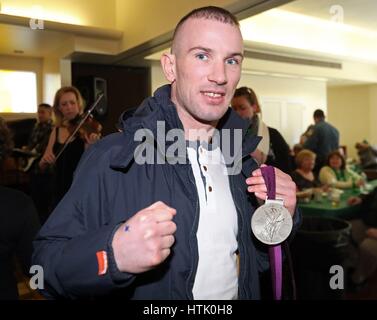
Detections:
0,70,37,113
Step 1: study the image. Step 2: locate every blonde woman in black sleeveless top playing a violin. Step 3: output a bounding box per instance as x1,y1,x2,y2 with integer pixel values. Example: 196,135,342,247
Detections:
39,87,101,208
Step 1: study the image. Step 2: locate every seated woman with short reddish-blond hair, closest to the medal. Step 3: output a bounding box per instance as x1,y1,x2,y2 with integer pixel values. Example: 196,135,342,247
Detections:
291,149,320,198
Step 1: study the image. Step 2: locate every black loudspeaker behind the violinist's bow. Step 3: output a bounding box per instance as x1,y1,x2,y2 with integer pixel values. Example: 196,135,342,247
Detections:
74,76,108,120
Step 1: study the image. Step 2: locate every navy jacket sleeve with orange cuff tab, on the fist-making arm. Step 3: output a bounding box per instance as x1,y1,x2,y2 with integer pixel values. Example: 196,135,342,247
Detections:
33,146,134,298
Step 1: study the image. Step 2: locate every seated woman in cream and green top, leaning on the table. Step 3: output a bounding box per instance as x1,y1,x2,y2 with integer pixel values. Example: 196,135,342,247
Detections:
319,151,364,189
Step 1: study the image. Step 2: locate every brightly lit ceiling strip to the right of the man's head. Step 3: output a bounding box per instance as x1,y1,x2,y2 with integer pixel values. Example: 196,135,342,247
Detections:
240,9,377,63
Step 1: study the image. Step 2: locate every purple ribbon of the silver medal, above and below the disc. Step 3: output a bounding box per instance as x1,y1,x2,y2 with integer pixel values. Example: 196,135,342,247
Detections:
260,166,282,300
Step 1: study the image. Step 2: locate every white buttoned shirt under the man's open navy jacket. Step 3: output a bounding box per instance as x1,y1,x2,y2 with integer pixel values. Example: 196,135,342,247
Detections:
187,146,238,300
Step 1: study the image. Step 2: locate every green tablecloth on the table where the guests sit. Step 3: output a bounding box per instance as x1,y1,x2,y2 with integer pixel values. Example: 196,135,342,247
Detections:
298,180,377,219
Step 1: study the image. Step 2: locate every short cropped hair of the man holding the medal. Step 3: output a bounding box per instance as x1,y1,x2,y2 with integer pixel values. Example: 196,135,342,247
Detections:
171,6,240,52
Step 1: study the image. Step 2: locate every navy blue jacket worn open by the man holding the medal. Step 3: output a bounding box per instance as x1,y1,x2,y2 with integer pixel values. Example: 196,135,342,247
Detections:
33,86,299,299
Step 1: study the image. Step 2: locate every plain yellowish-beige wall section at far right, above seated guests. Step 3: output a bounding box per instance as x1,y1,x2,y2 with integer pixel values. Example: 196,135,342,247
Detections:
327,85,377,159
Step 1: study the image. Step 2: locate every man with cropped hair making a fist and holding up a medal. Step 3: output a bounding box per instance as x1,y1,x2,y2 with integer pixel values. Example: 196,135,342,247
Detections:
34,7,299,299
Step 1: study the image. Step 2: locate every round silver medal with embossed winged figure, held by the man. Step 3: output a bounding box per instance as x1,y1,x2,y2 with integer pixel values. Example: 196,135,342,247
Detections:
251,200,293,245
